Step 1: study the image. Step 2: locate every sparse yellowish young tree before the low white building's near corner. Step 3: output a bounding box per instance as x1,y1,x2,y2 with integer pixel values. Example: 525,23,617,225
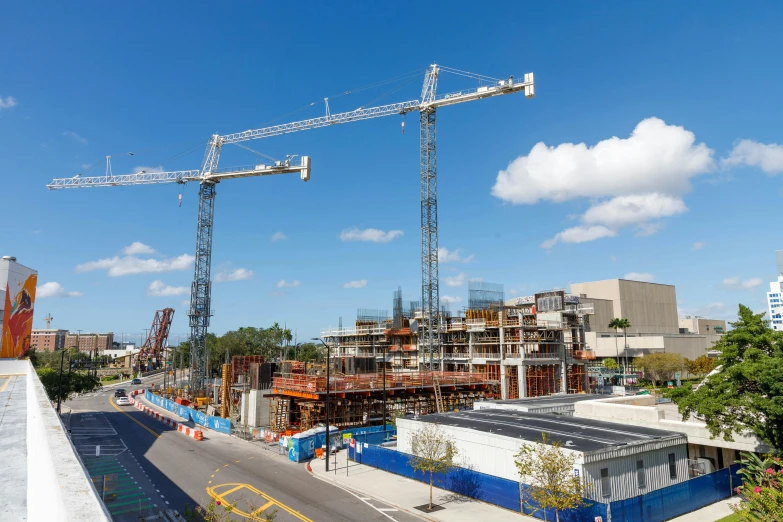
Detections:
514,433,584,522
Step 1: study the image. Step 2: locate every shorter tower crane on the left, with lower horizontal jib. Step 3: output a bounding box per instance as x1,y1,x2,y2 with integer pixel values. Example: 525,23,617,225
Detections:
46,150,310,392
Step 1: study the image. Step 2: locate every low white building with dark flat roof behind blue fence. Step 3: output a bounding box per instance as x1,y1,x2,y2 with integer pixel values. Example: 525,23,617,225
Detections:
397,410,688,503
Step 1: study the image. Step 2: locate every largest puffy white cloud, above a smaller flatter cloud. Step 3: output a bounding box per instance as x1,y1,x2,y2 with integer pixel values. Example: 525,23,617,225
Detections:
492,118,714,204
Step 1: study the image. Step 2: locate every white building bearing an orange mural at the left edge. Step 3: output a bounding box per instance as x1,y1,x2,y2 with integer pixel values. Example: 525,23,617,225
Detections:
0,256,38,358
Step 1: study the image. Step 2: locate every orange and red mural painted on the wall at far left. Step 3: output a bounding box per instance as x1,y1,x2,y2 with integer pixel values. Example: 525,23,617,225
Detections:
0,272,38,357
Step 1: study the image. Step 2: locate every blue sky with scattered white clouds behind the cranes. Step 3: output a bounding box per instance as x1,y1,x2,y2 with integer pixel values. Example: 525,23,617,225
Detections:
0,1,783,340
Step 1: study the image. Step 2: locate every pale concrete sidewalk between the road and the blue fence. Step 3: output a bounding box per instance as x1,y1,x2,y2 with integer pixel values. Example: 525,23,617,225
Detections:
308,450,537,522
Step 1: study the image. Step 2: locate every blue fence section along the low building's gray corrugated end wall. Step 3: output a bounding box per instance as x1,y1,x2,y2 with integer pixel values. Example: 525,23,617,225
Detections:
610,464,742,522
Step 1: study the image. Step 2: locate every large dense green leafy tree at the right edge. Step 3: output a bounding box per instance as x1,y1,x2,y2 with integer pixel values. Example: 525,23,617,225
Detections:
670,305,783,451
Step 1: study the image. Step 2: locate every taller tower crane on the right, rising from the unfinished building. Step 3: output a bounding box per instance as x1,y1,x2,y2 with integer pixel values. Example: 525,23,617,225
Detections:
207,64,535,370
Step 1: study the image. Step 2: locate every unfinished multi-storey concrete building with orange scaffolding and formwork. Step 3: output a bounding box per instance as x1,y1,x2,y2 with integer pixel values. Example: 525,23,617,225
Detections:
251,283,595,432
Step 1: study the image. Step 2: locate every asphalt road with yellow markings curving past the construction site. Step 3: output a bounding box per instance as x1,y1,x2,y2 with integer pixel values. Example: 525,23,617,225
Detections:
68,377,420,522
